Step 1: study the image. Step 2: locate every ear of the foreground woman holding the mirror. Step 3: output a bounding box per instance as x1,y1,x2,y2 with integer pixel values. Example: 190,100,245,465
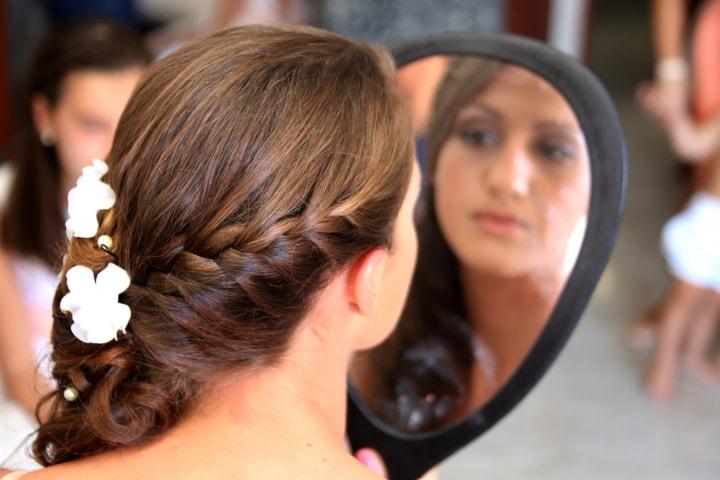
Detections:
346,248,389,317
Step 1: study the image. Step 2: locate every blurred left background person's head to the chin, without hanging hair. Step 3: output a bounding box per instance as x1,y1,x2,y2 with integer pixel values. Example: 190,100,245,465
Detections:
28,21,151,179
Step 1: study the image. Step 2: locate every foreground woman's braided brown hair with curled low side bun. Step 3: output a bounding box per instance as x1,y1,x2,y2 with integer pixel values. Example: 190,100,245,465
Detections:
33,23,412,465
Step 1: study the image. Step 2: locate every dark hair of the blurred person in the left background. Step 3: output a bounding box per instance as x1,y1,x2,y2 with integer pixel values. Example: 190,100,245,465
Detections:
0,20,151,267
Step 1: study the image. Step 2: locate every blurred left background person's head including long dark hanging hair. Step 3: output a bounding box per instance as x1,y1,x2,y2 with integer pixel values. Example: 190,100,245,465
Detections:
2,20,151,265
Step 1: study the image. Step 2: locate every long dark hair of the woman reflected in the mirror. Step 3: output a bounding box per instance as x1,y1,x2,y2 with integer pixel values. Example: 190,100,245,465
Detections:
361,57,503,432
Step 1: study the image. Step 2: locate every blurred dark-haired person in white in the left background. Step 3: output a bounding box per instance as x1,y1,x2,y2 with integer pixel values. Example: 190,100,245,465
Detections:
0,21,150,413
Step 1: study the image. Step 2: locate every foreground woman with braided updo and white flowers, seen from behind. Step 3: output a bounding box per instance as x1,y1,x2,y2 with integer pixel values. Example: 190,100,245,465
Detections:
2,27,419,479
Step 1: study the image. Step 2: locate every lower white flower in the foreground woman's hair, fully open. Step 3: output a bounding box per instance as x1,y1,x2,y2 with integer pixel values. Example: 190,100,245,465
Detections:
60,263,130,343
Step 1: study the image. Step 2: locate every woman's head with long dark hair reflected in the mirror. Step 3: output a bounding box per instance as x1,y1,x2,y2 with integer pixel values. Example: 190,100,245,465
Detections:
359,57,590,432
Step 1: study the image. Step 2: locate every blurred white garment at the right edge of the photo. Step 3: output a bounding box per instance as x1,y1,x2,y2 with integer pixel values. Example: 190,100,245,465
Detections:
661,192,720,292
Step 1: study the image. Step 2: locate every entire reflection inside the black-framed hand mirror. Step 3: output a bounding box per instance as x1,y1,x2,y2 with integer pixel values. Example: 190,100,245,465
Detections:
351,56,590,433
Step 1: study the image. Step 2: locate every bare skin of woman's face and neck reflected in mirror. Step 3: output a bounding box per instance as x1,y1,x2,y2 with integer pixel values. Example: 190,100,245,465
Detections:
432,67,590,416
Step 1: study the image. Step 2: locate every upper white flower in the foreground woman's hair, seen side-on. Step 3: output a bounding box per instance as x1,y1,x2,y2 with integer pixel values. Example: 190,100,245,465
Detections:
65,159,115,239
